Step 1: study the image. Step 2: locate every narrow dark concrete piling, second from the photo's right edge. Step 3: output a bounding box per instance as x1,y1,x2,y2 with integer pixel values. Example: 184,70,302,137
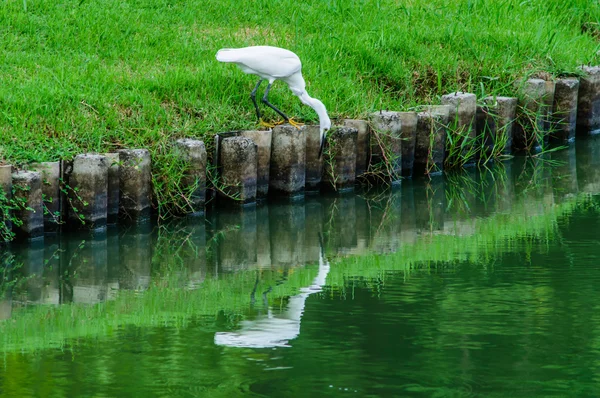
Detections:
550,77,579,146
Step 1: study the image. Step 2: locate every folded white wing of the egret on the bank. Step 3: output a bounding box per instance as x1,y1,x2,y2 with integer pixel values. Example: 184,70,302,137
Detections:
226,46,302,78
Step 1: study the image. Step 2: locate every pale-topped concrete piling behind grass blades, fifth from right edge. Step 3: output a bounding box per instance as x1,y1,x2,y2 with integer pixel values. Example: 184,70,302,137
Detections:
442,91,477,165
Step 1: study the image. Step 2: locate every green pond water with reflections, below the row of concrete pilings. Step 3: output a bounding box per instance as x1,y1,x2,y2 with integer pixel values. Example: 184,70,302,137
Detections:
0,140,600,397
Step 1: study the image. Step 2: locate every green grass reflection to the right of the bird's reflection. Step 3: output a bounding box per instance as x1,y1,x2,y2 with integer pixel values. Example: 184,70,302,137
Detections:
327,195,591,287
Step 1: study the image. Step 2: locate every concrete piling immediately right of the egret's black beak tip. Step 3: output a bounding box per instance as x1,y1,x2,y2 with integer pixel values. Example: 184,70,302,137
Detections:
323,127,358,192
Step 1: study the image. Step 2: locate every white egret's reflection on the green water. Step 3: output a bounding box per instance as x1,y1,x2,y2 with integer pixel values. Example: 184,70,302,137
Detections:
215,239,329,348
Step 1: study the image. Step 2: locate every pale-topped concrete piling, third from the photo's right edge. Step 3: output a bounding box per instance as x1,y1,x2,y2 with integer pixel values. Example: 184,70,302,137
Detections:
513,79,554,153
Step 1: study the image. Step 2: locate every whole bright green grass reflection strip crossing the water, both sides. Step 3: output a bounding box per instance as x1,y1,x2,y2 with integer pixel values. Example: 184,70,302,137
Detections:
0,191,590,351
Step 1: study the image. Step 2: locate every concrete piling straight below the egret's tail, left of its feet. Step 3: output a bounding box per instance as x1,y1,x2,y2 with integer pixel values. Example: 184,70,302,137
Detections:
218,137,257,204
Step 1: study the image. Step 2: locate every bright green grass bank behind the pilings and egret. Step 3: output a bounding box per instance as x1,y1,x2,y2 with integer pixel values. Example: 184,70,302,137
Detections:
0,0,600,215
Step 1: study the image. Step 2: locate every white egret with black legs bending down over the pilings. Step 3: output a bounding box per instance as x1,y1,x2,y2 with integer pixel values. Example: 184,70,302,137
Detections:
217,46,331,154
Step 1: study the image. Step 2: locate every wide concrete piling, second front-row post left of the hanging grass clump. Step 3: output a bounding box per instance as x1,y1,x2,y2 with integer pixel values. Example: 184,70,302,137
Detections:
67,154,109,229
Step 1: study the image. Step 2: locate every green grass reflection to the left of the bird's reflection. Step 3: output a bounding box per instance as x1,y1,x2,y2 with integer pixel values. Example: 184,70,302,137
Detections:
0,266,316,351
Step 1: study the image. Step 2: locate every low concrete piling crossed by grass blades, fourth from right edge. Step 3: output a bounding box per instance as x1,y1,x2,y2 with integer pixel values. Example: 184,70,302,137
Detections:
477,96,517,154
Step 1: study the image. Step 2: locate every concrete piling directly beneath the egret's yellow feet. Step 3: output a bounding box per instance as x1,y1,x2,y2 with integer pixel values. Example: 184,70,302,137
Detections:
269,124,312,198
